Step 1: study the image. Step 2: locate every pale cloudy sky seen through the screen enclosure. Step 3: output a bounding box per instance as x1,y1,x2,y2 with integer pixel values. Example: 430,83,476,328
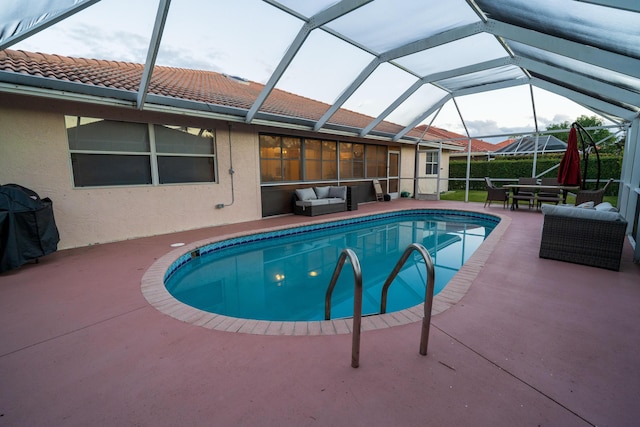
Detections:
10,0,595,142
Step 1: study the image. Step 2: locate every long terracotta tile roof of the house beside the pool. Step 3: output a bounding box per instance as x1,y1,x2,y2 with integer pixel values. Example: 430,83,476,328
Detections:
0,49,432,139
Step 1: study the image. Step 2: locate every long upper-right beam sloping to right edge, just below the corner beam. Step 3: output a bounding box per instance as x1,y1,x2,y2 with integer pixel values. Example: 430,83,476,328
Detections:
486,19,640,78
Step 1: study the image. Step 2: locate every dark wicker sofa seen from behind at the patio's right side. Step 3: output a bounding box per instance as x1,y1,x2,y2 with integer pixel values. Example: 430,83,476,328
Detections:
539,203,627,271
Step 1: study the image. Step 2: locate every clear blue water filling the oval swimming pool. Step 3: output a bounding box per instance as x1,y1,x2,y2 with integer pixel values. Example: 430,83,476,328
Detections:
165,209,499,321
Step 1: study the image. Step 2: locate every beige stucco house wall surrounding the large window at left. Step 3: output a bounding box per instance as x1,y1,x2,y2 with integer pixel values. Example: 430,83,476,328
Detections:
0,105,261,249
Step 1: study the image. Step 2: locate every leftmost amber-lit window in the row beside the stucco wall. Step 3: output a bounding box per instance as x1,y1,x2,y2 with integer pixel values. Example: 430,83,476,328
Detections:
260,135,302,182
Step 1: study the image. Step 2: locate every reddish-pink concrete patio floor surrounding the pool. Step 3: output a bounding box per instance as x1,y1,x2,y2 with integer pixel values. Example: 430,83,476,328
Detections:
0,200,640,426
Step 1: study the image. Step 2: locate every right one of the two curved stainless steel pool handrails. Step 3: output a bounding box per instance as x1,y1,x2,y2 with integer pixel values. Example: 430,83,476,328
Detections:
380,243,436,356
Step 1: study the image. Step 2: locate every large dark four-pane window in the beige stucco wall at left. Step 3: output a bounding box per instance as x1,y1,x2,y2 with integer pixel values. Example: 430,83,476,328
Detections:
65,117,216,187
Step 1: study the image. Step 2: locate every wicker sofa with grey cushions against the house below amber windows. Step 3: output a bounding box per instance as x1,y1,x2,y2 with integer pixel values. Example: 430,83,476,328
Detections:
293,185,347,216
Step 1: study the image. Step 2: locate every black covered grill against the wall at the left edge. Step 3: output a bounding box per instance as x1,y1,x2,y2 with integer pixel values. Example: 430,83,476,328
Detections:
0,184,60,272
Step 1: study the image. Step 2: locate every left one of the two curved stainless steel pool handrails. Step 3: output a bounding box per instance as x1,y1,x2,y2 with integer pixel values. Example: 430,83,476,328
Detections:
324,248,362,368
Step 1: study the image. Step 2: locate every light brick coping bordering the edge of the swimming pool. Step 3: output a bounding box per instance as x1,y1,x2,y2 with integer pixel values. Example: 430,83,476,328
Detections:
140,208,511,336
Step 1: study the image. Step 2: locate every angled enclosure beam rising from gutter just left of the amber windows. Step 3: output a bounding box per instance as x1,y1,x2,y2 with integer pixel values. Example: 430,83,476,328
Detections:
245,0,373,123
